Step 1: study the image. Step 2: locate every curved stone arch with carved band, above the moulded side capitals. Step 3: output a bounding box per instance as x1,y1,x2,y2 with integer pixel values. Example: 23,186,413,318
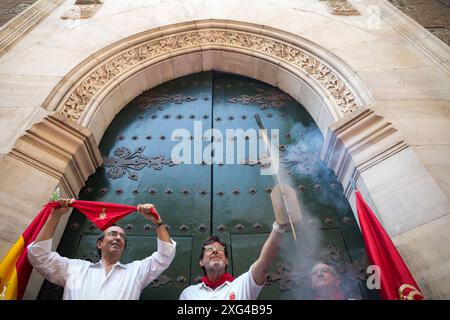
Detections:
44,20,371,133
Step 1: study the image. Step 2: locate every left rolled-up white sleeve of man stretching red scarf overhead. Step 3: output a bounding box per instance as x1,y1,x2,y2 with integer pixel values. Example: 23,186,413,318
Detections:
27,239,69,287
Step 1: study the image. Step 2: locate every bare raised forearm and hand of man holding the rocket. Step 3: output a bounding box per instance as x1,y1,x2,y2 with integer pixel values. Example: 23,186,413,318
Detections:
251,222,288,286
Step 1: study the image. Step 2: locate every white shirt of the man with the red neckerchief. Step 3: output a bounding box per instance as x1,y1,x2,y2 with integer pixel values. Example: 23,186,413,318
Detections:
180,267,264,300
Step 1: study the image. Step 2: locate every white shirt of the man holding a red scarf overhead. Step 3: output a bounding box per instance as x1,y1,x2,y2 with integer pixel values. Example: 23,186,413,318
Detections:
28,239,176,300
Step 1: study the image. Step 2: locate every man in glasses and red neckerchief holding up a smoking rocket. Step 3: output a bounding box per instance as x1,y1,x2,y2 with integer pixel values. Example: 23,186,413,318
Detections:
180,222,288,300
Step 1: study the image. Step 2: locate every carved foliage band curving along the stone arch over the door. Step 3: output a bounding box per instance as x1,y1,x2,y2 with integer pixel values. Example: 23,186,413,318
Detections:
61,29,359,121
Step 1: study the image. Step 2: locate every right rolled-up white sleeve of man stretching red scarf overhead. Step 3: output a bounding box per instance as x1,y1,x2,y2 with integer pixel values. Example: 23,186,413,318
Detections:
138,239,177,289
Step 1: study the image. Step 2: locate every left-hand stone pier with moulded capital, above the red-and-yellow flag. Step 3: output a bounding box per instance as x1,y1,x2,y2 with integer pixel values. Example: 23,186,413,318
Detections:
0,113,102,294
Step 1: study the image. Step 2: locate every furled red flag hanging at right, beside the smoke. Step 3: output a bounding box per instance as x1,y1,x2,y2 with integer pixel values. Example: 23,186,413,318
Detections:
356,190,424,300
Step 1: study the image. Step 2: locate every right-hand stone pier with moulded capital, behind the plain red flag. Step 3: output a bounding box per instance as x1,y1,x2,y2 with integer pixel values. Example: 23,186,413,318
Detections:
321,109,450,299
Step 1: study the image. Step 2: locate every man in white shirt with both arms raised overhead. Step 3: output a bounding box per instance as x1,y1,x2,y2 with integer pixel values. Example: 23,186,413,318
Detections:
28,199,176,300
